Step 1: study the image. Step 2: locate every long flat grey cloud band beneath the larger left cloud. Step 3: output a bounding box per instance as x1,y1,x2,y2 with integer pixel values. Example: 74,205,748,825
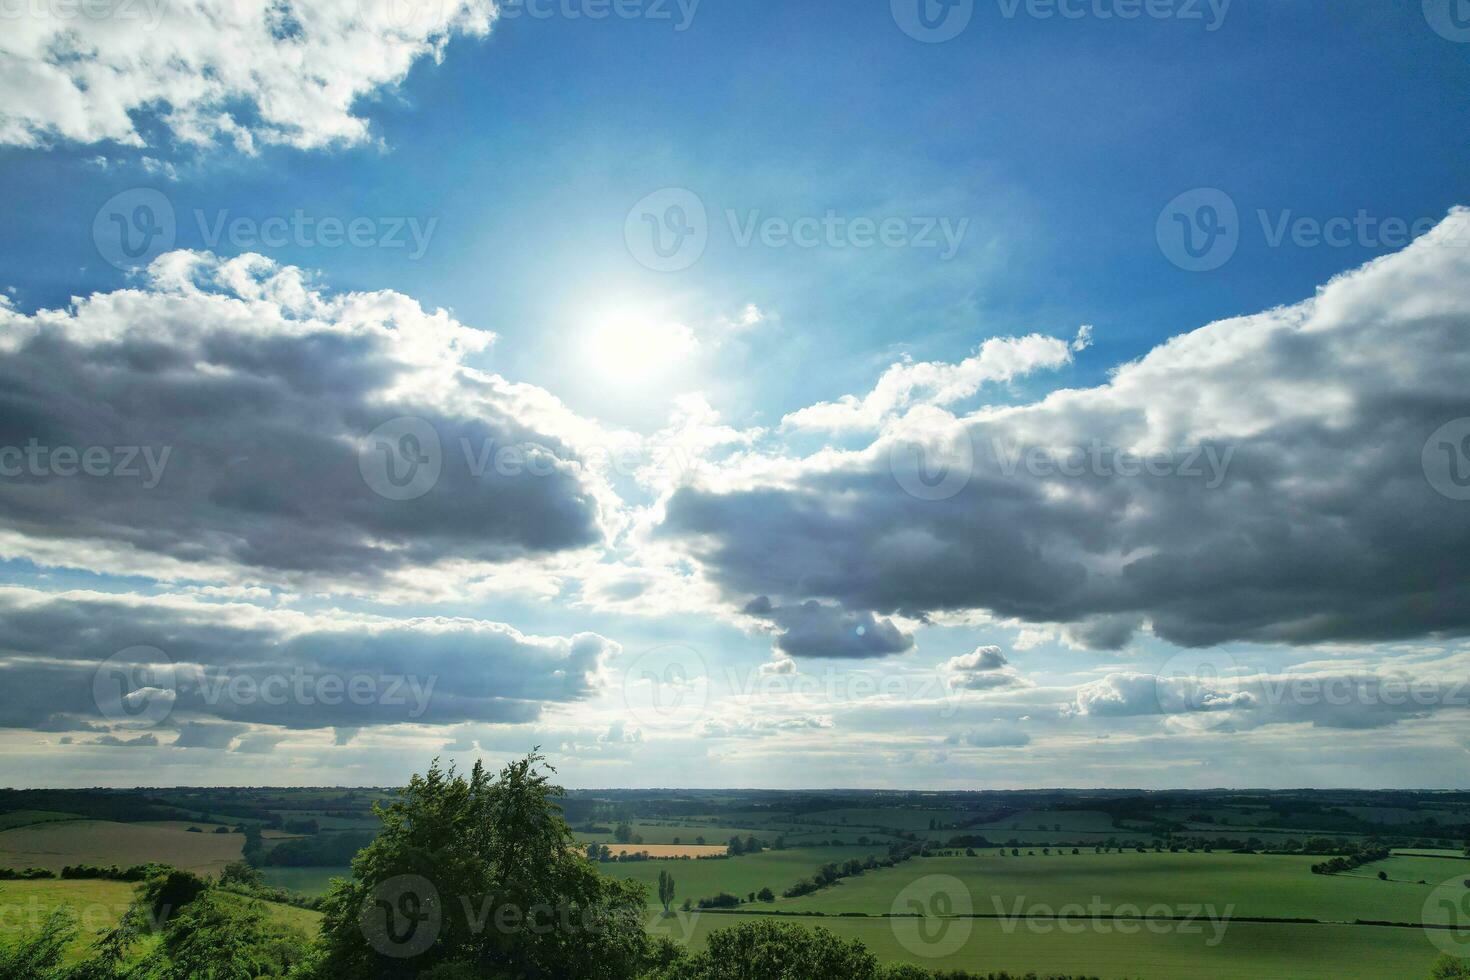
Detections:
0,586,617,734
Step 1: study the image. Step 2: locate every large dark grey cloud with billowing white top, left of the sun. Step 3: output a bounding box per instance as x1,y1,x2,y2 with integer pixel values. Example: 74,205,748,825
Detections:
0,251,604,595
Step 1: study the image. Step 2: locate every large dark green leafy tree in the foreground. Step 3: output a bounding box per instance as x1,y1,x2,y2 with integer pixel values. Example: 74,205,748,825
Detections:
310,752,648,980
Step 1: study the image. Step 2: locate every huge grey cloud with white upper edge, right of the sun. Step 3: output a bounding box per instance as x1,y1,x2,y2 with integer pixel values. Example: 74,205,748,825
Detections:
659,210,1470,648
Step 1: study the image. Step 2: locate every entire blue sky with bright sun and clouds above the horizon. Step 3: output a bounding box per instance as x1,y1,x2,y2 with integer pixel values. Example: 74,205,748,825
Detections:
0,0,1470,789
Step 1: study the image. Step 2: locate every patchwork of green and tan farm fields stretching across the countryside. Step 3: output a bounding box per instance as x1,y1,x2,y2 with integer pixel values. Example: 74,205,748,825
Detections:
0,790,1470,980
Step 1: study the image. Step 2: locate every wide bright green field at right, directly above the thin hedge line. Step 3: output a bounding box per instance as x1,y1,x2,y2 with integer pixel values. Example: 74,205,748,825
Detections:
778,851,1454,923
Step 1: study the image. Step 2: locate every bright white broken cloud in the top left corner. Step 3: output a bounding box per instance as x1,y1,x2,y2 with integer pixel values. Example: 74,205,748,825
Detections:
0,0,495,153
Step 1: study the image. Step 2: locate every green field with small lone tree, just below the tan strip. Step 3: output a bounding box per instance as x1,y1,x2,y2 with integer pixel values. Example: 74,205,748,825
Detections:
597,846,886,907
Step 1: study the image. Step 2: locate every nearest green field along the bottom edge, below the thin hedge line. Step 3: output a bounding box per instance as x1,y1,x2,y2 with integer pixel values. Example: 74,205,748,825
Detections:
667,914,1439,980
